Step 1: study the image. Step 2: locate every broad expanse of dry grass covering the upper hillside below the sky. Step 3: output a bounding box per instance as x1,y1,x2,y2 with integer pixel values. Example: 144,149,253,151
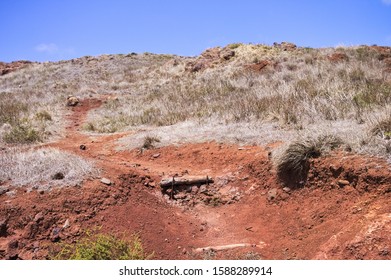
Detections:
0,43,391,162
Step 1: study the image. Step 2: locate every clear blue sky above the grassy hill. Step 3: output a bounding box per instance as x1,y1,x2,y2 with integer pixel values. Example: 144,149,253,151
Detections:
0,0,391,62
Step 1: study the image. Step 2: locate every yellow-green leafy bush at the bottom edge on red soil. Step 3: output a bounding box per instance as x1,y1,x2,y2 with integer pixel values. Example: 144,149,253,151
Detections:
53,231,150,260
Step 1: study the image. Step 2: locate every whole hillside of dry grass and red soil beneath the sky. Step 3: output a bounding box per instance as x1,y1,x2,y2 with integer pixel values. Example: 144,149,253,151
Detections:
0,42,391,259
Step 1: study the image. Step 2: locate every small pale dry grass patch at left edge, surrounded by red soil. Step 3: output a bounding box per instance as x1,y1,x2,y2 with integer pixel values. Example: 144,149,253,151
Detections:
0,148,98,189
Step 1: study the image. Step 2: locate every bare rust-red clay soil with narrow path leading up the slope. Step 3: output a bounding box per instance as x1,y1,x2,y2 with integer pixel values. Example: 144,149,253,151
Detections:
0,99,391,259
